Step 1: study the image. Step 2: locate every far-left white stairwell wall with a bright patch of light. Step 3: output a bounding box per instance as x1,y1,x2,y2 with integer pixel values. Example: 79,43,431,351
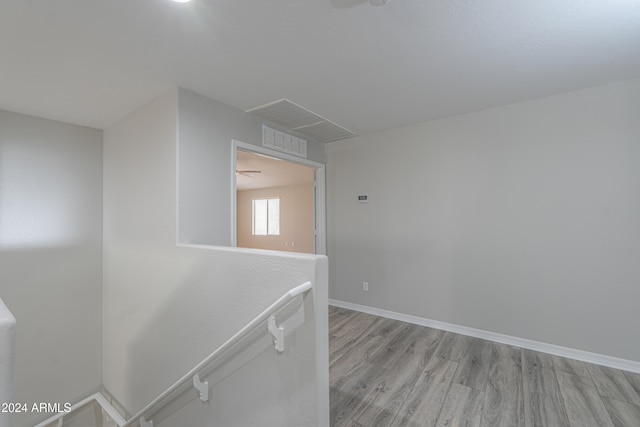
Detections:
0,111,102,427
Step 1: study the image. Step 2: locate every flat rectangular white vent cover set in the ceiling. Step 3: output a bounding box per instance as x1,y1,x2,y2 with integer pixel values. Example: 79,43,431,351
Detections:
247,99,356,142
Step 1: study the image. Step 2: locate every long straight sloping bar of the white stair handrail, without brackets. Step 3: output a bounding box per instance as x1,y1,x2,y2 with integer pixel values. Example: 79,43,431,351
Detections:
121,282,312,427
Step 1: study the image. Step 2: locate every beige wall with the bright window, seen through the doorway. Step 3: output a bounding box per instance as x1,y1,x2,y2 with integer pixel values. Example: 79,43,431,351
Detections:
237,185,314,253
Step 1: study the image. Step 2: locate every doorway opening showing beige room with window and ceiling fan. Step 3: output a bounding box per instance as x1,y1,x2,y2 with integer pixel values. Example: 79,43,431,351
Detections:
231,141,326,254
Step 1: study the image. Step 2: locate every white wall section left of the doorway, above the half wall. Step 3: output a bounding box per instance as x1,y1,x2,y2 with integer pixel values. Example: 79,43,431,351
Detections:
178,89,324,246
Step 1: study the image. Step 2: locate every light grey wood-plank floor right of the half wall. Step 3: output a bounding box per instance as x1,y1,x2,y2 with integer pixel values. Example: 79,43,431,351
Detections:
329,307,640,427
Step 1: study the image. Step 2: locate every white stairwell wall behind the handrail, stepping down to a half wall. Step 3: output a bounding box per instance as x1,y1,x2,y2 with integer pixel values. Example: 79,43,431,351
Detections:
104,90,328,426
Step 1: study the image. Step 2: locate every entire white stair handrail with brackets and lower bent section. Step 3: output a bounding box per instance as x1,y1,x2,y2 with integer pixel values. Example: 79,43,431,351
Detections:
35,282,312,427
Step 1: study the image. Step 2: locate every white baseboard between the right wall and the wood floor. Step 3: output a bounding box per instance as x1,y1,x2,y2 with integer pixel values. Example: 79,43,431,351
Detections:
329,299,640,373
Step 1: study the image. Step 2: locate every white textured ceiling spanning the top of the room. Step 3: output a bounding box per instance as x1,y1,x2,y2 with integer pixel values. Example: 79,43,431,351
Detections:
0,0,640,134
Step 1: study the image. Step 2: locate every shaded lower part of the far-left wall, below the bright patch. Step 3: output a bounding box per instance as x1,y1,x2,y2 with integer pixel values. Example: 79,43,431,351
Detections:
0,246,102,427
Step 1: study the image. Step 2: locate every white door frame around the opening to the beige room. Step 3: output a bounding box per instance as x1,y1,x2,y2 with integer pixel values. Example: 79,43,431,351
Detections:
231,139,327,255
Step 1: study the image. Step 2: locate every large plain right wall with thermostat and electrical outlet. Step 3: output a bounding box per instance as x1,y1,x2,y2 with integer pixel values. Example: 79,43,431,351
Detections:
327,80,640,361
